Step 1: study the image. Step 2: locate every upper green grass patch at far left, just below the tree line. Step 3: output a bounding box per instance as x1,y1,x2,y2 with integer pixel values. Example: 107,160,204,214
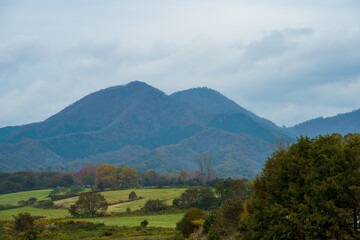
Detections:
0,189,52,206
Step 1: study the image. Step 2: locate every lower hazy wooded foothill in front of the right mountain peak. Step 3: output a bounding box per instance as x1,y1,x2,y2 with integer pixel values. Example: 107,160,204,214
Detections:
121,128,272,178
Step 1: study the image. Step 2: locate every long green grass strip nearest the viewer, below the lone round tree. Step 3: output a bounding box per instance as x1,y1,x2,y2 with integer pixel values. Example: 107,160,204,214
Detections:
83,213,185,228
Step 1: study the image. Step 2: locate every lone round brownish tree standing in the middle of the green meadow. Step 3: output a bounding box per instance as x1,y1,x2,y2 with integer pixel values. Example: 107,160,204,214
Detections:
69,192,108,217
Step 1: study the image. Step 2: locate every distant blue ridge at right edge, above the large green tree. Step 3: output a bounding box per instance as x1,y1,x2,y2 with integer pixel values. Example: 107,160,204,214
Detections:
288,109,360,137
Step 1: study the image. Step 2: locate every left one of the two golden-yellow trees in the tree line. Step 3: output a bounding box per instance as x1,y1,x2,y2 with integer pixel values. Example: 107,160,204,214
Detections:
95,163,117,187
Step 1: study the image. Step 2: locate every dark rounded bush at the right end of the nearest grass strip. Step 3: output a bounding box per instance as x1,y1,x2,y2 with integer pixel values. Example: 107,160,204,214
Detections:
176,208,204,238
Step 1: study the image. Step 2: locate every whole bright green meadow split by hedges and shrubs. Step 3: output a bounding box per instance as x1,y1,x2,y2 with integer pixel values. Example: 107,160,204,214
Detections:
0,188,185,228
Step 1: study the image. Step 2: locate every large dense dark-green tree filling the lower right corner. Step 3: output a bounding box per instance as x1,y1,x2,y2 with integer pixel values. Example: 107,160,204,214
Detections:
240,134,360,239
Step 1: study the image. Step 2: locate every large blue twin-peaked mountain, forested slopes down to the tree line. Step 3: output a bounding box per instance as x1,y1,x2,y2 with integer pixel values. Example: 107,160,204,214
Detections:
0,81,287,176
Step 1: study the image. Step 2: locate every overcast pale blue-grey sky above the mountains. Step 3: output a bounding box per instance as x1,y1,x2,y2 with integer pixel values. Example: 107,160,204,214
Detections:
0,0,360,127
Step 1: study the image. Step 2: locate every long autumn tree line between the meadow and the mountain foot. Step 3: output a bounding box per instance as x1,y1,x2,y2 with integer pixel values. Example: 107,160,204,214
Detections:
0,159,219,194
